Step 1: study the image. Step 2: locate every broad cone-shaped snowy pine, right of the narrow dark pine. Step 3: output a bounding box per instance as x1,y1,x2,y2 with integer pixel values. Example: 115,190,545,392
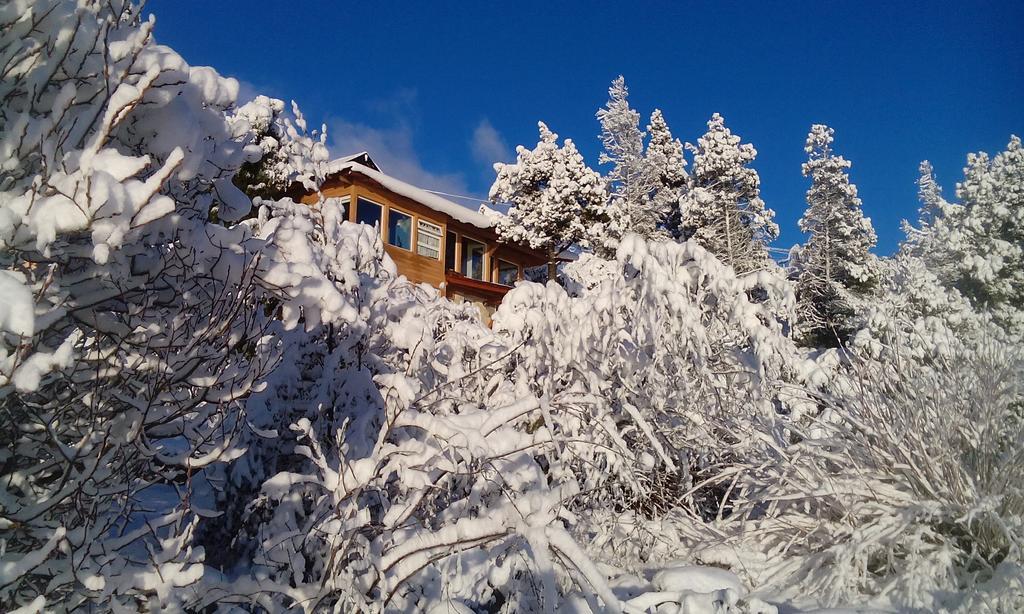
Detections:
683,113,778,273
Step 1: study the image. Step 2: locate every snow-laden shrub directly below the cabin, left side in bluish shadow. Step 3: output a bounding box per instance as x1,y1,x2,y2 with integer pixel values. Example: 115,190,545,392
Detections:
190,201,630,612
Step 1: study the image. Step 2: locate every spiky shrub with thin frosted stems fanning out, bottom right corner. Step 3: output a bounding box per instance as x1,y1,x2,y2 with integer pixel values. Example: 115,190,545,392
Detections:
737,336,1024,612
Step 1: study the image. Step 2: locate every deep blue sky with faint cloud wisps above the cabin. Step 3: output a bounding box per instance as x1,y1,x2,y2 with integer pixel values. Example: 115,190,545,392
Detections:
146,0,1024,254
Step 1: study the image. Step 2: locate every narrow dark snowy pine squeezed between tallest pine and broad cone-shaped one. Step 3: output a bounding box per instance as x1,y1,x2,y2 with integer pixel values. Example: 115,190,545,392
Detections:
645,108,688,238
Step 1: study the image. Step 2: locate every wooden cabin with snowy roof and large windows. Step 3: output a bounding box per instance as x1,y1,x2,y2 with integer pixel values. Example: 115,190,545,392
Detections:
298,152,547,321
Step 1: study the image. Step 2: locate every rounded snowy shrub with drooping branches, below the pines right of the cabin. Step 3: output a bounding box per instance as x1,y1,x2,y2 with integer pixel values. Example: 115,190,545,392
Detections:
494,235,813,564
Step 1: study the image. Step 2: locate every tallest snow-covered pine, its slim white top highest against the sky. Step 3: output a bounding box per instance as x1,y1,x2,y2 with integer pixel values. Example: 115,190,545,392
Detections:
592,76,662,249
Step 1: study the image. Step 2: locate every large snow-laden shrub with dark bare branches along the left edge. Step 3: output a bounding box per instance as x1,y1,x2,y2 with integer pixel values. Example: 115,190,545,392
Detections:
0,0,278,611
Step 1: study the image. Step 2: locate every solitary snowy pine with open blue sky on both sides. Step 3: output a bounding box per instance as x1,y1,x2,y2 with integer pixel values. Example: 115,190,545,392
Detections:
797,124,876,346
